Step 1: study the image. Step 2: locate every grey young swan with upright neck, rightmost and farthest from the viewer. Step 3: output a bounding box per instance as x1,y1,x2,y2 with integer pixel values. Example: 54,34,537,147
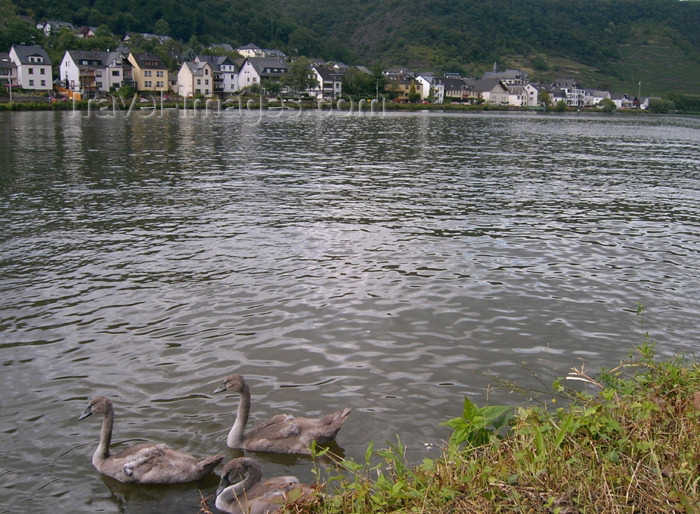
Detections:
209,375,351,455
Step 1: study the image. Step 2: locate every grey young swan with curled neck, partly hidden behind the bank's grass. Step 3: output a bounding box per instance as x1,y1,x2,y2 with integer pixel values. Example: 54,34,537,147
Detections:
215,457,313,514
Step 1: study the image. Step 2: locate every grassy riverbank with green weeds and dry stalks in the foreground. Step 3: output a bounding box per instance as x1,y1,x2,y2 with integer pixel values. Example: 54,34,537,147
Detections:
276,345,700,513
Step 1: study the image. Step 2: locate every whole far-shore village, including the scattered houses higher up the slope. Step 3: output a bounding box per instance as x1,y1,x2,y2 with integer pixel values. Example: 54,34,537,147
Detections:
0,21,650,109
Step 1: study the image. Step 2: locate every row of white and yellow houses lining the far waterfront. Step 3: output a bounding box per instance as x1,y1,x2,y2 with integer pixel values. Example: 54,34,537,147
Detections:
0,44,644,108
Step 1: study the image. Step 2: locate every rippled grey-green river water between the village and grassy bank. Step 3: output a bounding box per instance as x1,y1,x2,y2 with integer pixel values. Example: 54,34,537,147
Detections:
0,111,700,513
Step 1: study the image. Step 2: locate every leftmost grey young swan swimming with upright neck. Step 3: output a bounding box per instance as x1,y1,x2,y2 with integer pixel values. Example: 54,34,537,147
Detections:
78,396,224,484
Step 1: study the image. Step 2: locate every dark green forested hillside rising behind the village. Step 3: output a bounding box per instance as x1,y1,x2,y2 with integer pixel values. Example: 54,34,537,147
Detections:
5,0,700,92
